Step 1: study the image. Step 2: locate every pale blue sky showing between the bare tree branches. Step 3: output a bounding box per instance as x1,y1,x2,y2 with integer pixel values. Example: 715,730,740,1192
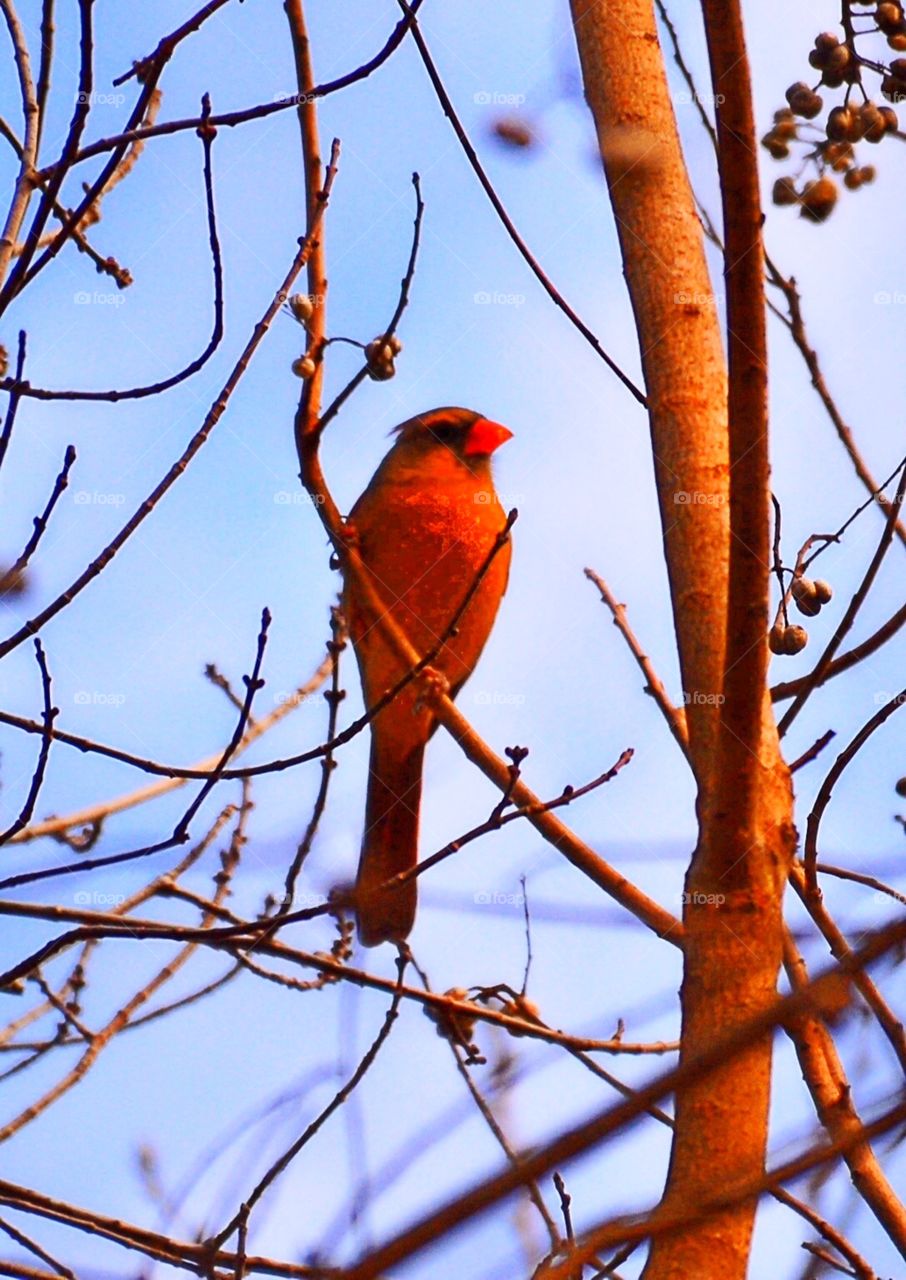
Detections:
0,0,906,1276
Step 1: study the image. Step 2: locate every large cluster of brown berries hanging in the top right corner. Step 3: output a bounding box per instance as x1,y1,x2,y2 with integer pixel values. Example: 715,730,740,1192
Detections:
761,0,906,223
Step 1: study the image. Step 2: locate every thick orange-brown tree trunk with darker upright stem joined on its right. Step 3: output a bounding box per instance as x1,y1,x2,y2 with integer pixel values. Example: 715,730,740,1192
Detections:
572,0,795,1280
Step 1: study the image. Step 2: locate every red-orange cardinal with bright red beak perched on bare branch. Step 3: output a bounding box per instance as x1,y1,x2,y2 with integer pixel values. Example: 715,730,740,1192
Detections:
343,408,512,947
